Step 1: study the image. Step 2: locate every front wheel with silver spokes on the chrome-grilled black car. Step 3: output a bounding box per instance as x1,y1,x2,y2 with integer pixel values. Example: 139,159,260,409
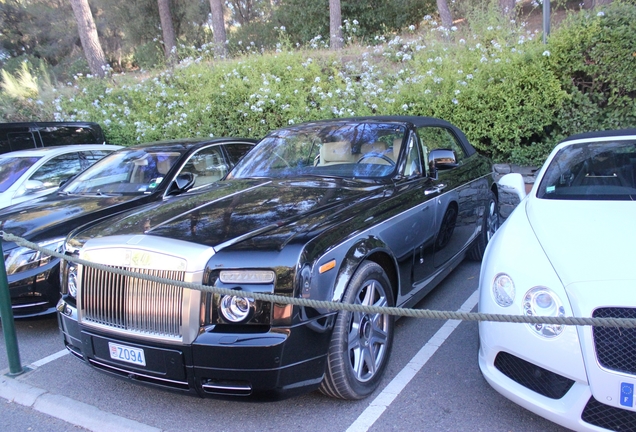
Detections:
320,261,394,400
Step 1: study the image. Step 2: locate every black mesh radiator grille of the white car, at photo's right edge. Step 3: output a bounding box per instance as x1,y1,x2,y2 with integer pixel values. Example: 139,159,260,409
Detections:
592,308,636,375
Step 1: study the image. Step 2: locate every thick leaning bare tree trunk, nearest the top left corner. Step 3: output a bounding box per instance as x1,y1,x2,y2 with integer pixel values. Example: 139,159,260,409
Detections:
70,0,107,78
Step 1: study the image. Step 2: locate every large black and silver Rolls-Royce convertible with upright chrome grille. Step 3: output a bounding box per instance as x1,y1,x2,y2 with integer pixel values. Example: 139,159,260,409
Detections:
58,117,498,399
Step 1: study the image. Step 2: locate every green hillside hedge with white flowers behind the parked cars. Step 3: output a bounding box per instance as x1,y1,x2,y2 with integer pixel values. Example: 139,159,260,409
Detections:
0,0,636,165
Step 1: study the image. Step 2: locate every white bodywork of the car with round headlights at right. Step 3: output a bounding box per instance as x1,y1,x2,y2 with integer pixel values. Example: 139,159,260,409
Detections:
479,130,636,431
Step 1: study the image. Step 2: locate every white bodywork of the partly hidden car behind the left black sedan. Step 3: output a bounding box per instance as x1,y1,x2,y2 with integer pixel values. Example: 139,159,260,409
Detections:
0,144,122,209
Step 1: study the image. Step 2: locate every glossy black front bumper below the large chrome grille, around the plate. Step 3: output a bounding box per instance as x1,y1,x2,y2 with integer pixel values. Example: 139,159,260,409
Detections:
58,300,331,399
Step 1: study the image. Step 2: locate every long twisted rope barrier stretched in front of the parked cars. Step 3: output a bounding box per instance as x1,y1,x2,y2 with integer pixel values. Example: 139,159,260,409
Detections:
0,231,636,328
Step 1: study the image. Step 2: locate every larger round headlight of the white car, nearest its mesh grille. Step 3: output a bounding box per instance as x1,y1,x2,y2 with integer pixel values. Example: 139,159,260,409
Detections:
523,287,565,338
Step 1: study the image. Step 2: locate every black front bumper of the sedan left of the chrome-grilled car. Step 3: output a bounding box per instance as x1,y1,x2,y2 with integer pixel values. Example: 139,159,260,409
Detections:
7,259,60,318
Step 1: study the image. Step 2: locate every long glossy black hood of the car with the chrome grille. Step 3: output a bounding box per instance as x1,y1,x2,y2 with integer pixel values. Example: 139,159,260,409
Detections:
74,179,384,251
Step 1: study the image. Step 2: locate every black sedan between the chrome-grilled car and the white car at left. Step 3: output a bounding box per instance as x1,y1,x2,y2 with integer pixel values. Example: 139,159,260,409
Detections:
0,138,255,317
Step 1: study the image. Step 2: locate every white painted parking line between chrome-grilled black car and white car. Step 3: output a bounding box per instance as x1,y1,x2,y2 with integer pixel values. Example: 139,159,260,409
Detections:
347,291,479,432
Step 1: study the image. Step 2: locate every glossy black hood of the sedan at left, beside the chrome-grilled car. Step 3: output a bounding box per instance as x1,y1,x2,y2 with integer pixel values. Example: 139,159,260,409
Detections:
0,194,147,242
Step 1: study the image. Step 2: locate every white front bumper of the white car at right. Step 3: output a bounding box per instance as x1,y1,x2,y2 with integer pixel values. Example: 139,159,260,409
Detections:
479,323,636,431
